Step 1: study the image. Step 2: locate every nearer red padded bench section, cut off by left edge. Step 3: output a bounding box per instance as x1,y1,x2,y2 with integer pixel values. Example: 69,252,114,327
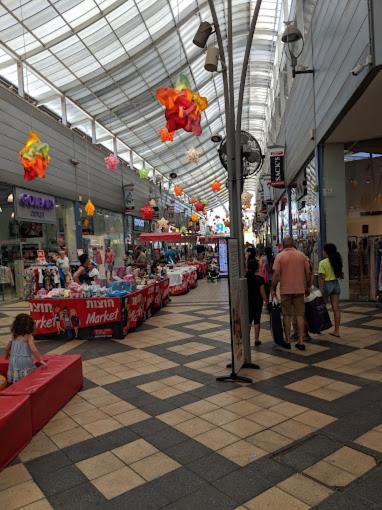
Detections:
0,392,32,471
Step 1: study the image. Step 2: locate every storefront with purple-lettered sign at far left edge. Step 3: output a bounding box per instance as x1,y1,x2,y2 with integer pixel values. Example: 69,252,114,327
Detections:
0,184,77,300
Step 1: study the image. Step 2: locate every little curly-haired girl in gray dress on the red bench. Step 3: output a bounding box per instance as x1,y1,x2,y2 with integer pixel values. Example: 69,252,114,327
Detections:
5,313,46,384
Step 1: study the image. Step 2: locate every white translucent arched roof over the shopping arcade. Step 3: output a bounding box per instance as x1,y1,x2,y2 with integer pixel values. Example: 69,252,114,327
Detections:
0,0,282,205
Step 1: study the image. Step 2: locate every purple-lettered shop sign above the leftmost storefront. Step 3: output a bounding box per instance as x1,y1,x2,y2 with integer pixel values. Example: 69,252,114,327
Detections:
15,188,57,223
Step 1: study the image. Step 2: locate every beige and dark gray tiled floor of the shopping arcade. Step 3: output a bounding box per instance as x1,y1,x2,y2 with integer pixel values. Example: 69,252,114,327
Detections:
0,281,382,510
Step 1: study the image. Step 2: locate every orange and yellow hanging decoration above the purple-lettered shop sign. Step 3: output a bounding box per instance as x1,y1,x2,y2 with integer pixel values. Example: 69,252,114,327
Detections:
19,131,50,181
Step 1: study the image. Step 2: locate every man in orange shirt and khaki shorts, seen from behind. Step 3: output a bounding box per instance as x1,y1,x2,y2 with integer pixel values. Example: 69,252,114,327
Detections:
272,237,310,351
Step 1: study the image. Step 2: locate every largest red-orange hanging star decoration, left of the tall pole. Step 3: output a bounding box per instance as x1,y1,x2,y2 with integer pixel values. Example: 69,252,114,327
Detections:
156,74,208,142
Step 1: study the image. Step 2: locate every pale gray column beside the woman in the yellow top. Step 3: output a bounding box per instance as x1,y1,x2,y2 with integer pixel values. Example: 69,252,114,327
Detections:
322,143,349,299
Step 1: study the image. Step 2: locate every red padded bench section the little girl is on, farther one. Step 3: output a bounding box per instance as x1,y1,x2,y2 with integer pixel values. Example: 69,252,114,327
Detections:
0,354,83,434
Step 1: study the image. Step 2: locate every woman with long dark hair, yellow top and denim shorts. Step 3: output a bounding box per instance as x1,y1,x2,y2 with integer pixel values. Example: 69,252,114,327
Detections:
318,243,343,338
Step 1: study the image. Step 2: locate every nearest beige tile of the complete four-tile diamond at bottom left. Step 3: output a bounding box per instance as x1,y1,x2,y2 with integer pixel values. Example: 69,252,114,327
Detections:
92,466,145,499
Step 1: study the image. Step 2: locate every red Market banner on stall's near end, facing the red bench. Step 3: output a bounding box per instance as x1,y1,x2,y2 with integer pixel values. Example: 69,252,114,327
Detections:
30,298,121,337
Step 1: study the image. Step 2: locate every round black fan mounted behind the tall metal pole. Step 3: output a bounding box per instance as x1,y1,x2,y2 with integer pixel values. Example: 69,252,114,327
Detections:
218,131,264,179
